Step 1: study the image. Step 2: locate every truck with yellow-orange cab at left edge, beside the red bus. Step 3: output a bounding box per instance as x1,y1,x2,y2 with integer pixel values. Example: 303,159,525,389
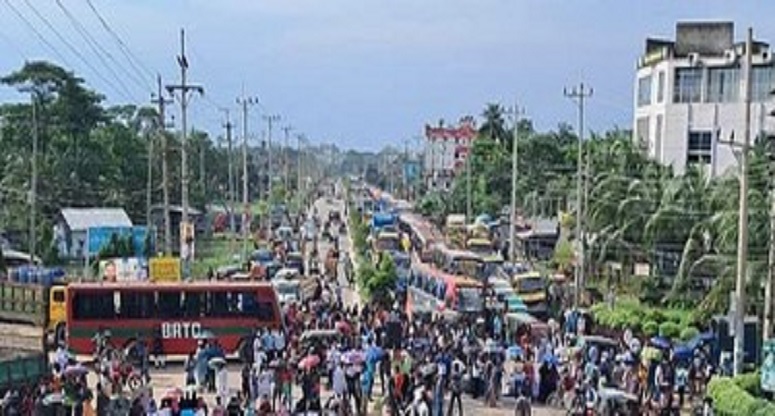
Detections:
0,268,67,344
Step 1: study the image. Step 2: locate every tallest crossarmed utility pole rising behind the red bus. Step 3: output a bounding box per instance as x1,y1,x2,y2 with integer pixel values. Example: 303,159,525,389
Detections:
167,29,204,278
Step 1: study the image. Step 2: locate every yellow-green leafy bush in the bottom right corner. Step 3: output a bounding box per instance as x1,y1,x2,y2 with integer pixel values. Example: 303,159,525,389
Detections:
707,375,775,416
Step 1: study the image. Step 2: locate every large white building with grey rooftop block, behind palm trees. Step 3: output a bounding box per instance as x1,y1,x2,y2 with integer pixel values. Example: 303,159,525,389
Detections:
633,22,775,175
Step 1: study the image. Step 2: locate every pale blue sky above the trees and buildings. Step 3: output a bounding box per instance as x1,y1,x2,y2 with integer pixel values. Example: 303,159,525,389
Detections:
0,0,775,150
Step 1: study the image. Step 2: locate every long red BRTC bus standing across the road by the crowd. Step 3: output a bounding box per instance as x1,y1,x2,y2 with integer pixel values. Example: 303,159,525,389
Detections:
66,282,283,355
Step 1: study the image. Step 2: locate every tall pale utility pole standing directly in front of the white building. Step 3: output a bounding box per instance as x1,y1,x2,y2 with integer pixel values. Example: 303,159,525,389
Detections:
734,28,753,375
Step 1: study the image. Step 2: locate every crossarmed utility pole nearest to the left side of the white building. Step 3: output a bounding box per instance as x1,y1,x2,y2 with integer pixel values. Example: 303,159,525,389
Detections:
563,82,593,308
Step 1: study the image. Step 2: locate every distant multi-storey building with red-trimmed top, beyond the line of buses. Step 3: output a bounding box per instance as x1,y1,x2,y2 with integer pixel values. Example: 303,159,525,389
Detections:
424,117,477,190
